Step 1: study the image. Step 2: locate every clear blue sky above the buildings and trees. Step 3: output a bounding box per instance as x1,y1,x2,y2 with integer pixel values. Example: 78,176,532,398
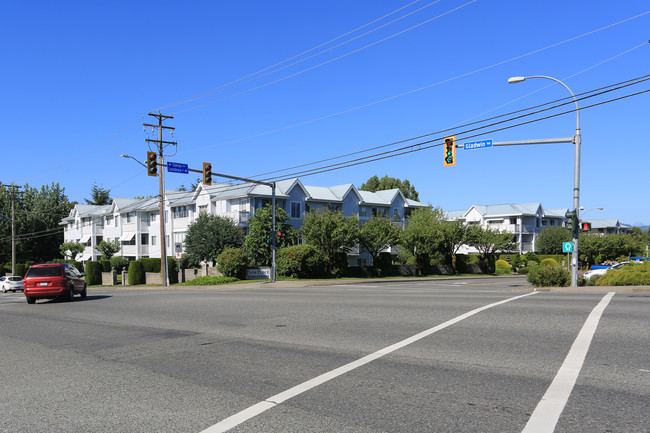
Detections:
0,0,650,224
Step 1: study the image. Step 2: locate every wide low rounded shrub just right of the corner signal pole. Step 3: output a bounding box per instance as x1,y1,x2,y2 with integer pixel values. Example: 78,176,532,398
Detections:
277,244,327,278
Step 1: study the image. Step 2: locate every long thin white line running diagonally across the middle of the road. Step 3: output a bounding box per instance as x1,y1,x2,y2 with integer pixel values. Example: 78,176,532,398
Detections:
201,292,539,433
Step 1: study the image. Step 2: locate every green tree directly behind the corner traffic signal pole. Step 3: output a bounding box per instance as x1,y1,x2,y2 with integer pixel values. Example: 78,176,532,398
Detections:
244,206,298,266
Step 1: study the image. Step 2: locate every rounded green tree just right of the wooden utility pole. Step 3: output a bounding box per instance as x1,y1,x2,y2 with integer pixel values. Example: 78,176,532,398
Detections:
185,212,243,261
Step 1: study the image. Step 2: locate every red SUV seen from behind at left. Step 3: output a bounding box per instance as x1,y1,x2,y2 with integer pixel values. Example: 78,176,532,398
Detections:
23,263,86,304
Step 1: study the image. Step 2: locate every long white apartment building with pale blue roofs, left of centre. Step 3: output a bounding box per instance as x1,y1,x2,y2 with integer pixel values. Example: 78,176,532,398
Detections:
60,178,425,265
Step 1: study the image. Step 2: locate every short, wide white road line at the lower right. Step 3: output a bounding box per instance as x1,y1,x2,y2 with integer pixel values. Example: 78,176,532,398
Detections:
522,292,614,433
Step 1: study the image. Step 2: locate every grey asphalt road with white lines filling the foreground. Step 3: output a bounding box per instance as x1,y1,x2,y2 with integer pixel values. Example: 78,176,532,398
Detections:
0,278,650,433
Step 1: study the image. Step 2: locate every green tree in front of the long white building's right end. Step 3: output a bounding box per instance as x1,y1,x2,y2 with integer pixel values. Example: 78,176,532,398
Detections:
399,206,444,274
